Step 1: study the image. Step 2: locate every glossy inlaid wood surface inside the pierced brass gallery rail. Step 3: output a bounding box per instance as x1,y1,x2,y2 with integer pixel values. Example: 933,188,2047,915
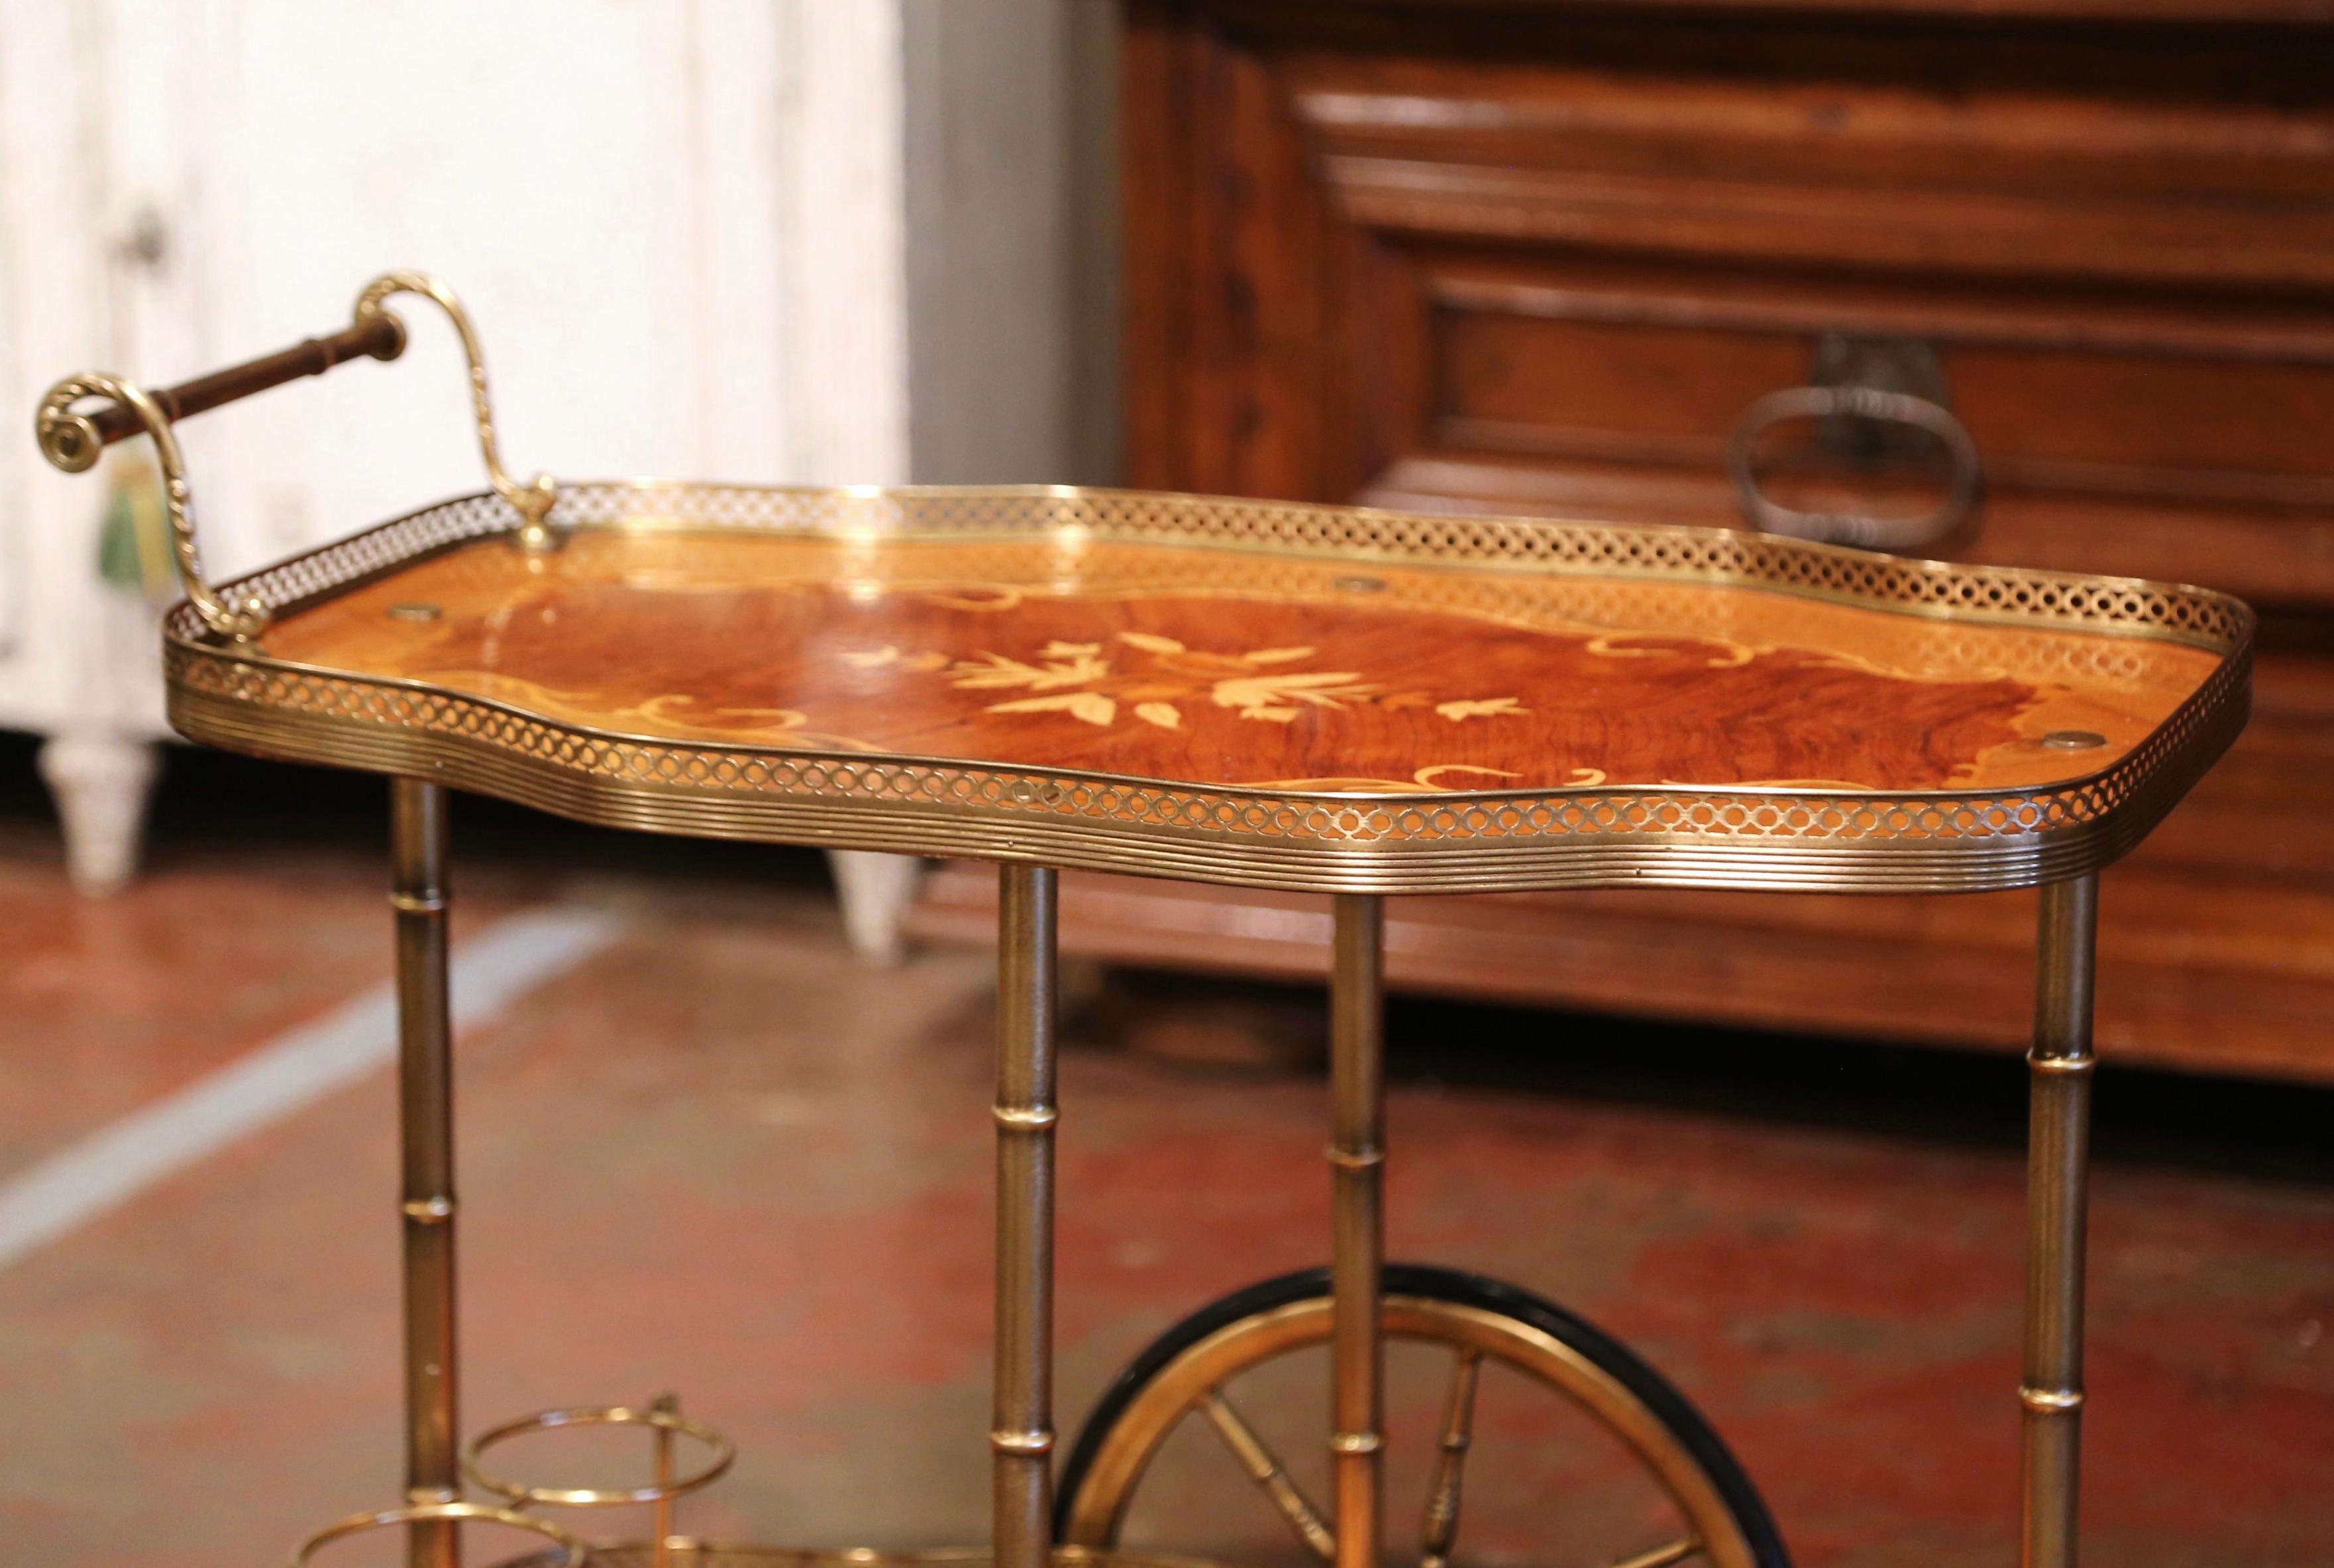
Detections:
266,527,2217,791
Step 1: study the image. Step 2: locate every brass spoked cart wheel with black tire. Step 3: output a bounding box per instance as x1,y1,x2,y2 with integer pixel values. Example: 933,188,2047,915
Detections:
1055,1265,1790,1568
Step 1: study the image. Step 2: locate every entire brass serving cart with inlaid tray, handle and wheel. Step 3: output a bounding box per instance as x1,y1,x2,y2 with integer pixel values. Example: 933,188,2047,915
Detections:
37,273,2253,1568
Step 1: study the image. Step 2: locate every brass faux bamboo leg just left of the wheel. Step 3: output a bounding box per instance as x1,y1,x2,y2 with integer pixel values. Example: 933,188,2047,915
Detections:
990,866,1057,1568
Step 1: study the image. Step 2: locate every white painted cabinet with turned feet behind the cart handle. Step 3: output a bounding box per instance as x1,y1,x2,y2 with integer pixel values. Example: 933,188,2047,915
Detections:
0,0,1081,940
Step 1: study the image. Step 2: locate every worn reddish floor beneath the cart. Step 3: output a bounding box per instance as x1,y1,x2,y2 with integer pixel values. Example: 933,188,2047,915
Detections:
0,751,2334,1568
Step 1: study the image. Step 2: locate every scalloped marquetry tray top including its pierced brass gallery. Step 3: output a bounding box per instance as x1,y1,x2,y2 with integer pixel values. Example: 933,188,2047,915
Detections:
168,486,2250,892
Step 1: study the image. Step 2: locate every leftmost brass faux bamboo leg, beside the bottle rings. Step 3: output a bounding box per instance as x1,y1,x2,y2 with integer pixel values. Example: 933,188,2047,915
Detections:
390,779,462,1568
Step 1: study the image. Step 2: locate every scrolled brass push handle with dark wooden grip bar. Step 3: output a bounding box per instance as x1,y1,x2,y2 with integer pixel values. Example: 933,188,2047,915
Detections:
32,273,558,642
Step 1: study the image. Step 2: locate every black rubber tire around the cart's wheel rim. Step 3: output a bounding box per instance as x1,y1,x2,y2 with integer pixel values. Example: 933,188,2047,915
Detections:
1055,1263,1790,1568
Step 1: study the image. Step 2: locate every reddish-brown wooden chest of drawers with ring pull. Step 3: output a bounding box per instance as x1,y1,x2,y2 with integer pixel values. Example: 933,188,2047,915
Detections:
927,0,2334,1080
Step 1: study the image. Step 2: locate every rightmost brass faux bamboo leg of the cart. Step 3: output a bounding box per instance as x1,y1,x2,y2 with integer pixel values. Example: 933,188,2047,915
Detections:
2019,872,2098,1568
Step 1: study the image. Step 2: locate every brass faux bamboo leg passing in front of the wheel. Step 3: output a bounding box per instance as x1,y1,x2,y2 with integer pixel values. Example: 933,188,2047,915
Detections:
1328,894,1387,1568
